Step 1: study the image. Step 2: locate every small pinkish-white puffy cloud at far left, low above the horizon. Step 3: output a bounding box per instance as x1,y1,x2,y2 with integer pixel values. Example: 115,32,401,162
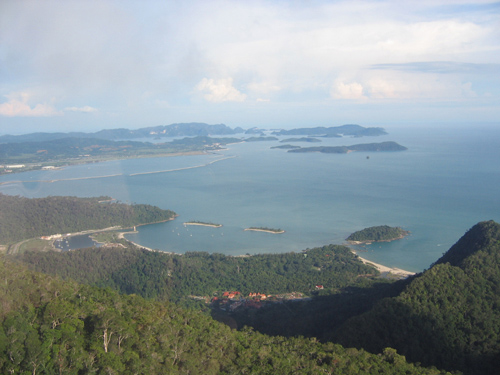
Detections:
0,92,61,117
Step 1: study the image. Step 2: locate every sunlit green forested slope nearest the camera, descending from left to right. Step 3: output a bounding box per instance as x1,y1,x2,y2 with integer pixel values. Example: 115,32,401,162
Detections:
0,257,450,375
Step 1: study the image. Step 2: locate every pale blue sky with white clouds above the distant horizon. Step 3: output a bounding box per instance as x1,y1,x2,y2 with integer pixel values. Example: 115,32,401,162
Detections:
0,0,500,134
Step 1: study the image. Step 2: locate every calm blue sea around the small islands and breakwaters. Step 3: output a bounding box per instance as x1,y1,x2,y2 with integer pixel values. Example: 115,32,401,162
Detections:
0,125,500,272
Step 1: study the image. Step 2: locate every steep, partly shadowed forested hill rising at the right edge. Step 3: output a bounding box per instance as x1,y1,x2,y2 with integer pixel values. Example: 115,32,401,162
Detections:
336,221,500,374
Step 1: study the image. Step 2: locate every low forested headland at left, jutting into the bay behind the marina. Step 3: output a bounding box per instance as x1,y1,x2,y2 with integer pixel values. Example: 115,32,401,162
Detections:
0,193,175,244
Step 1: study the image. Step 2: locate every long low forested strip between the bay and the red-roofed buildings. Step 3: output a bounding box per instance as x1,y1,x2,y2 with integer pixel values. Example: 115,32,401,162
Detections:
11,245,378,304
